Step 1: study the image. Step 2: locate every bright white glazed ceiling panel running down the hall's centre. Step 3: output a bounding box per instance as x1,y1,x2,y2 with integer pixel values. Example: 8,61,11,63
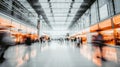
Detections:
39,0,83,30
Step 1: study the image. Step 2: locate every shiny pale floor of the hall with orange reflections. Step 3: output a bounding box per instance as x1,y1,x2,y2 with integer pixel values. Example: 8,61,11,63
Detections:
0,41,120,67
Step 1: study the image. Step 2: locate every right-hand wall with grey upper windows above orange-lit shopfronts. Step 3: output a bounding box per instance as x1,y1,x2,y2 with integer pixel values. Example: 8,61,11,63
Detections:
70,0,120,45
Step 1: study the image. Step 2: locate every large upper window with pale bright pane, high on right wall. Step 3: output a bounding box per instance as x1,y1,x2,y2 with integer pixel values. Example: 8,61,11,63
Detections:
98,0,114,20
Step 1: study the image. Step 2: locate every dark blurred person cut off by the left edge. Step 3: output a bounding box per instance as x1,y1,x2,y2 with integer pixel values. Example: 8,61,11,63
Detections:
0,30,15,63
